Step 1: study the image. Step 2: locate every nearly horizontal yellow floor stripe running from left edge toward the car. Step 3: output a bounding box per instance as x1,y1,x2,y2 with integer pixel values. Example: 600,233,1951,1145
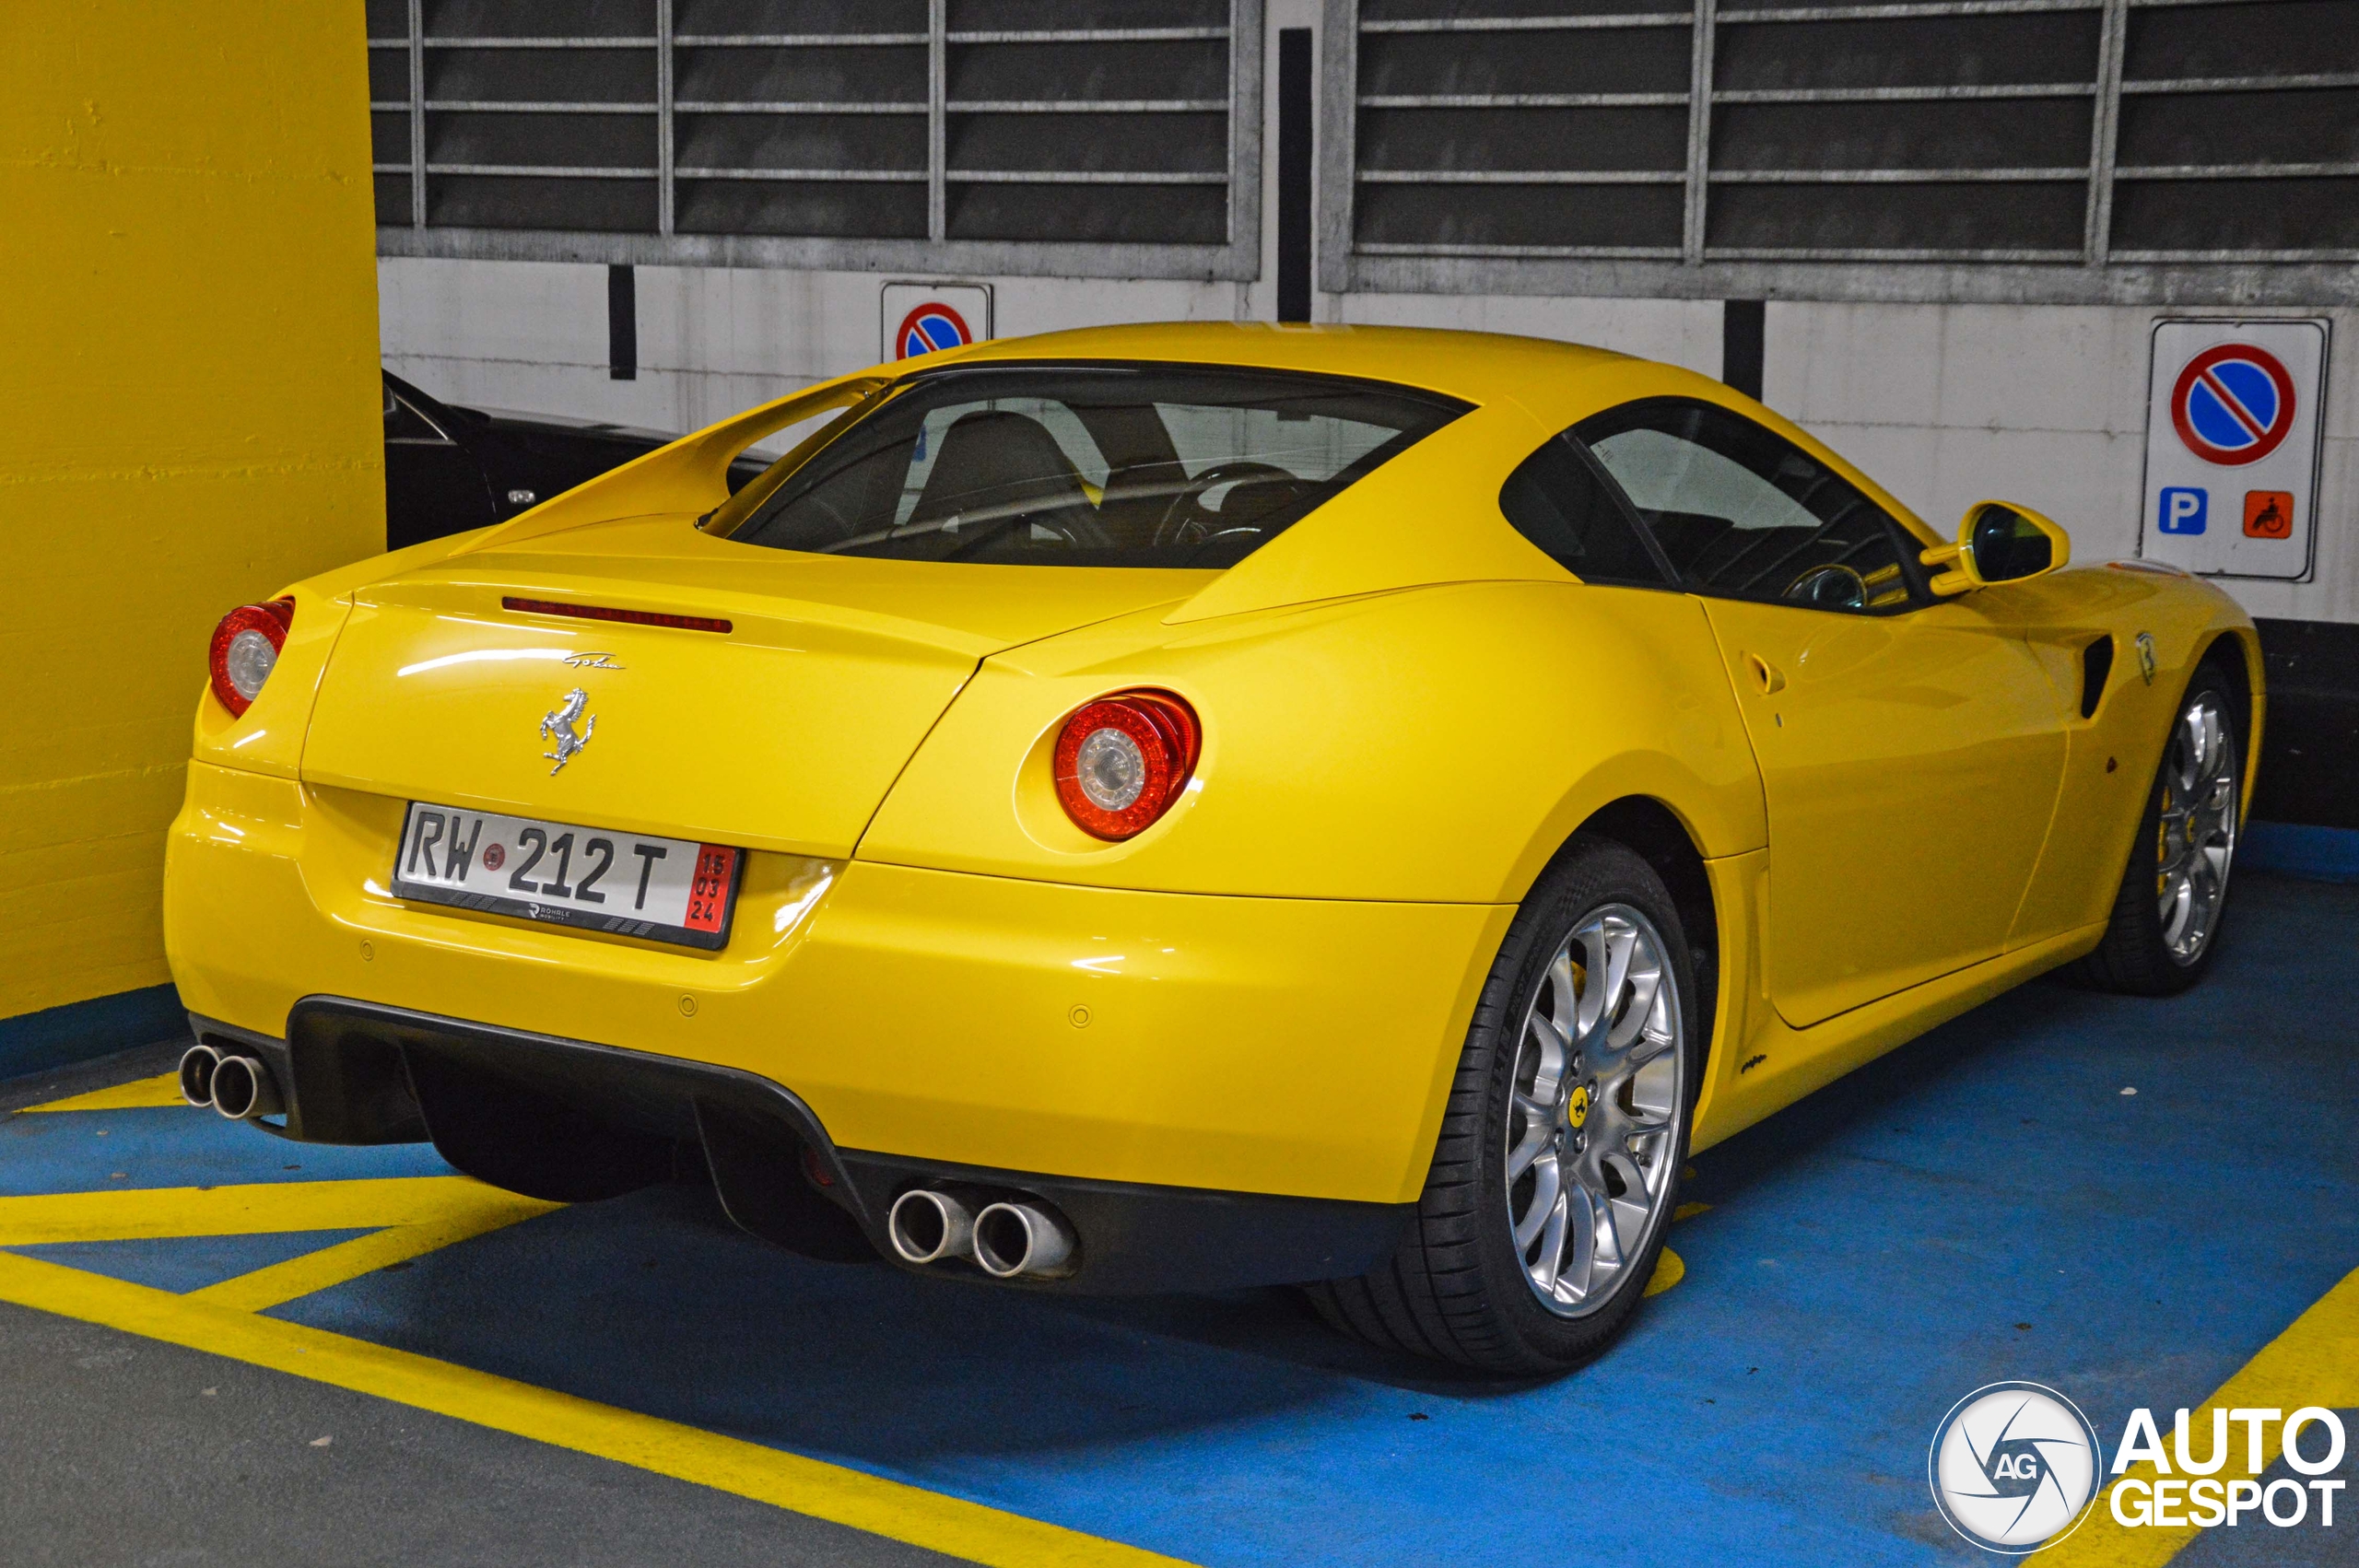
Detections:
0,1176,528,1247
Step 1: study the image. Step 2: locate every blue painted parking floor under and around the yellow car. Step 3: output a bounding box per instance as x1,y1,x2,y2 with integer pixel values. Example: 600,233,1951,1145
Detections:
0,877,2359,1568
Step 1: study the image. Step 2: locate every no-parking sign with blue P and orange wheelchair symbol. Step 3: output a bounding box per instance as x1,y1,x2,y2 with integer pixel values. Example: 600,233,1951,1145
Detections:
2137,319,2326,580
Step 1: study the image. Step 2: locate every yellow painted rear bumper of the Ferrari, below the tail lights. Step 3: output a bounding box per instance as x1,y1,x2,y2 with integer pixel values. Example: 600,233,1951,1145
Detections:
165,764,1512,1205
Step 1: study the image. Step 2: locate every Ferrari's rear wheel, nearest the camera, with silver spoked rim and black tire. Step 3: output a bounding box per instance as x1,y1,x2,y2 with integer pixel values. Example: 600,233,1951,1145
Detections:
1309,839,1703,1373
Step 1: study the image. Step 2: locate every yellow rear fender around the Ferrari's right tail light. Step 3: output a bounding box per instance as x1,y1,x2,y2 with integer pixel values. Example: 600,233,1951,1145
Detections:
854,582,1766,903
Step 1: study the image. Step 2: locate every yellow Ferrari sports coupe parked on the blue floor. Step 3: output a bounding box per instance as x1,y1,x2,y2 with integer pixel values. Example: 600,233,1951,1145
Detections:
165,325,2262,1370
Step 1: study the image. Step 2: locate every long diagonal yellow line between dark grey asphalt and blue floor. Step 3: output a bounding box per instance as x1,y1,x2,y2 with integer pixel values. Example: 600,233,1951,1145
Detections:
0,1252,1177,1568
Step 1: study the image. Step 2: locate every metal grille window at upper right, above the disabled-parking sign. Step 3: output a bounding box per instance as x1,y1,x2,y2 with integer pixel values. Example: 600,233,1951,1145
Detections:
1321,0,2359,302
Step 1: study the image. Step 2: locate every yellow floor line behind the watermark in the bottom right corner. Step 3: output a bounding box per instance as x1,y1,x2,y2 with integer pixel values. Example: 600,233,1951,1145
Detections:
2040,1269,2359,1568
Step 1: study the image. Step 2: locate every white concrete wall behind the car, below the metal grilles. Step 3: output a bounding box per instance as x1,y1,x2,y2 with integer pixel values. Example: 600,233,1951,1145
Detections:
378,0,2359,620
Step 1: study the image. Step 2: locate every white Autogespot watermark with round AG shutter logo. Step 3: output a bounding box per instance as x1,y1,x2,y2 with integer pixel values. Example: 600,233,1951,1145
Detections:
1925,1382,2347,1556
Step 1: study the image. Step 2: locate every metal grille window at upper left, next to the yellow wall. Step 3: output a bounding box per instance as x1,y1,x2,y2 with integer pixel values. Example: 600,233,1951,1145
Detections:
368,0,1262,278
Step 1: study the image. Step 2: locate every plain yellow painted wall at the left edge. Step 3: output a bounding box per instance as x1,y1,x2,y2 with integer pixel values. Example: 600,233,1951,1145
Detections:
0,0,384,1019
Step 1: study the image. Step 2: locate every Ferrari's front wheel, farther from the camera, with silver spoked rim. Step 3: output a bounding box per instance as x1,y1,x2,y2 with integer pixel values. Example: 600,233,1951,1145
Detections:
2078,661,2250,998
